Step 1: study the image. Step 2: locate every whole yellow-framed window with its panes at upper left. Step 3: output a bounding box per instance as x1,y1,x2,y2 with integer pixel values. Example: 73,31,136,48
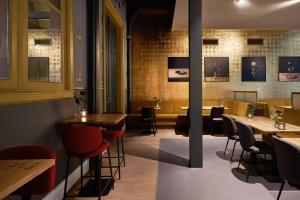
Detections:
0,0,73,105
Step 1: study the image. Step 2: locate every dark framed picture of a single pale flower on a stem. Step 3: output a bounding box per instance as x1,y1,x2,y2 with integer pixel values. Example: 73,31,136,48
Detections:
242,57,266,81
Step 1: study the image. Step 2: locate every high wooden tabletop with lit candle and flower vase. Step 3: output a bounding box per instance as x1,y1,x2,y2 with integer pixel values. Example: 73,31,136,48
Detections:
58,114,127,126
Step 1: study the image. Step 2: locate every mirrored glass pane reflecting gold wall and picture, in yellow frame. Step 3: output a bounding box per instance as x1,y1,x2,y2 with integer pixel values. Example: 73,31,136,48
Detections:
28,0,62,83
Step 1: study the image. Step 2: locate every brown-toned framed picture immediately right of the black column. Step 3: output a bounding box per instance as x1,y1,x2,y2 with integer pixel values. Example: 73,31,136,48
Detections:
204,57,229,82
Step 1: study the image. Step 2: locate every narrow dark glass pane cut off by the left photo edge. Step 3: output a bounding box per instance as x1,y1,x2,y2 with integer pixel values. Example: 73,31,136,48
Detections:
0,0,10,79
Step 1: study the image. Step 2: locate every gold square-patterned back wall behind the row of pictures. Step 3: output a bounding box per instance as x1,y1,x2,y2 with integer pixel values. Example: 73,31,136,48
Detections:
132,16,300,100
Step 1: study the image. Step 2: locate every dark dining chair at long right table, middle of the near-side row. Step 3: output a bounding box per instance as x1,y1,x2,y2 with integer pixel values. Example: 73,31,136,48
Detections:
237,122,274,182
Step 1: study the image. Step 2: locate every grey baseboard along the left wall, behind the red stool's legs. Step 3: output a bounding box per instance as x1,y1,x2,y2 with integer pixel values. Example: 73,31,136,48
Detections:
43,159,89,200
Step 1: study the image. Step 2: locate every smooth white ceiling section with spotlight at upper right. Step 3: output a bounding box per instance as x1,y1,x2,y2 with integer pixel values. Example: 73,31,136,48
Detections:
172,0,300,29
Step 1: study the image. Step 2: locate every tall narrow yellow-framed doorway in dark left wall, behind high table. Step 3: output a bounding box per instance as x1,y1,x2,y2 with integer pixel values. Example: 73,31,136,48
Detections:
103,0,124,112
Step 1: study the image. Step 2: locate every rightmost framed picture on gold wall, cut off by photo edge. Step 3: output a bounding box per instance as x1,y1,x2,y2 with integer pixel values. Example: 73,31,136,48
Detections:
278,57,300,82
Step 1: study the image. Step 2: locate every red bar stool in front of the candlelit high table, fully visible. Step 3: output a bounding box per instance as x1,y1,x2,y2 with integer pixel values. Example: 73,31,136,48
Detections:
62,126,112,199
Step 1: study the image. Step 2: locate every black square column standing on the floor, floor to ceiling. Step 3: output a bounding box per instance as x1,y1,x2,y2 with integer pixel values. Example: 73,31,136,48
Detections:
189,0,203,168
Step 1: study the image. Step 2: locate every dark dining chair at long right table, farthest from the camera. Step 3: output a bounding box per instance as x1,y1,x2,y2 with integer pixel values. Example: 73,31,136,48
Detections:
223,116,240,163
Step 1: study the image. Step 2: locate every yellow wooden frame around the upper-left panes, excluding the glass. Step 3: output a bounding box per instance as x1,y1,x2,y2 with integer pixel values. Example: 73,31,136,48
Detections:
0,0,74,106
